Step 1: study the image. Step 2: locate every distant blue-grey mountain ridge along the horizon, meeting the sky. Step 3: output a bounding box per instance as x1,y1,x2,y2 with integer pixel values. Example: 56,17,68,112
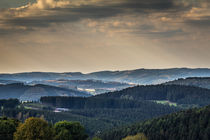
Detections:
0,68,210,84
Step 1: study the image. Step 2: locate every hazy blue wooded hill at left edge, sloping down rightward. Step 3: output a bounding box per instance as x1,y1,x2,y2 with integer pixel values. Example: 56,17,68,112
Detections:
0,83,90,101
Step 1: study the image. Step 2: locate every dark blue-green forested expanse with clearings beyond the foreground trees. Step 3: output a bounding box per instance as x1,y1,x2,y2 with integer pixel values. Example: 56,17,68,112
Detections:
1,85,210,135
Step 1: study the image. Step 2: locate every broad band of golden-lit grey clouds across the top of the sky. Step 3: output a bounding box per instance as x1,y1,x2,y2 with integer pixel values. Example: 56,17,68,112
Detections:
0,0,210,37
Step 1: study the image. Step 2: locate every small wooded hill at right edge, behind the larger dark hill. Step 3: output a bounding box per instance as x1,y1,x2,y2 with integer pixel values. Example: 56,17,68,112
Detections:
165,77,210,89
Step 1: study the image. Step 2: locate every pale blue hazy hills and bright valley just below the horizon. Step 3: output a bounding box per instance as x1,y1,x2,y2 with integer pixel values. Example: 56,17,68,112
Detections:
0,68,210,96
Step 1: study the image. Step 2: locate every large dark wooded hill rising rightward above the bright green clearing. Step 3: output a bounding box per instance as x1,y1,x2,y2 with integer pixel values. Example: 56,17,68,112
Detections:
95,85,210,106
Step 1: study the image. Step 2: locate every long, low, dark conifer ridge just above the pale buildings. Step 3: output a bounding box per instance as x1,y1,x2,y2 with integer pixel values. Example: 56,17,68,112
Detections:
40,96,177,112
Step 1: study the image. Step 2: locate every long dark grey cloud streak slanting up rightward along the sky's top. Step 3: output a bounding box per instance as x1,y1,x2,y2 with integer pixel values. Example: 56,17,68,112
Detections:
0,0,189,27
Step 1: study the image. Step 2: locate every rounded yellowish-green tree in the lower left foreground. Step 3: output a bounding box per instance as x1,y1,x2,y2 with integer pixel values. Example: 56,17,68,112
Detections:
14,117,53,140
